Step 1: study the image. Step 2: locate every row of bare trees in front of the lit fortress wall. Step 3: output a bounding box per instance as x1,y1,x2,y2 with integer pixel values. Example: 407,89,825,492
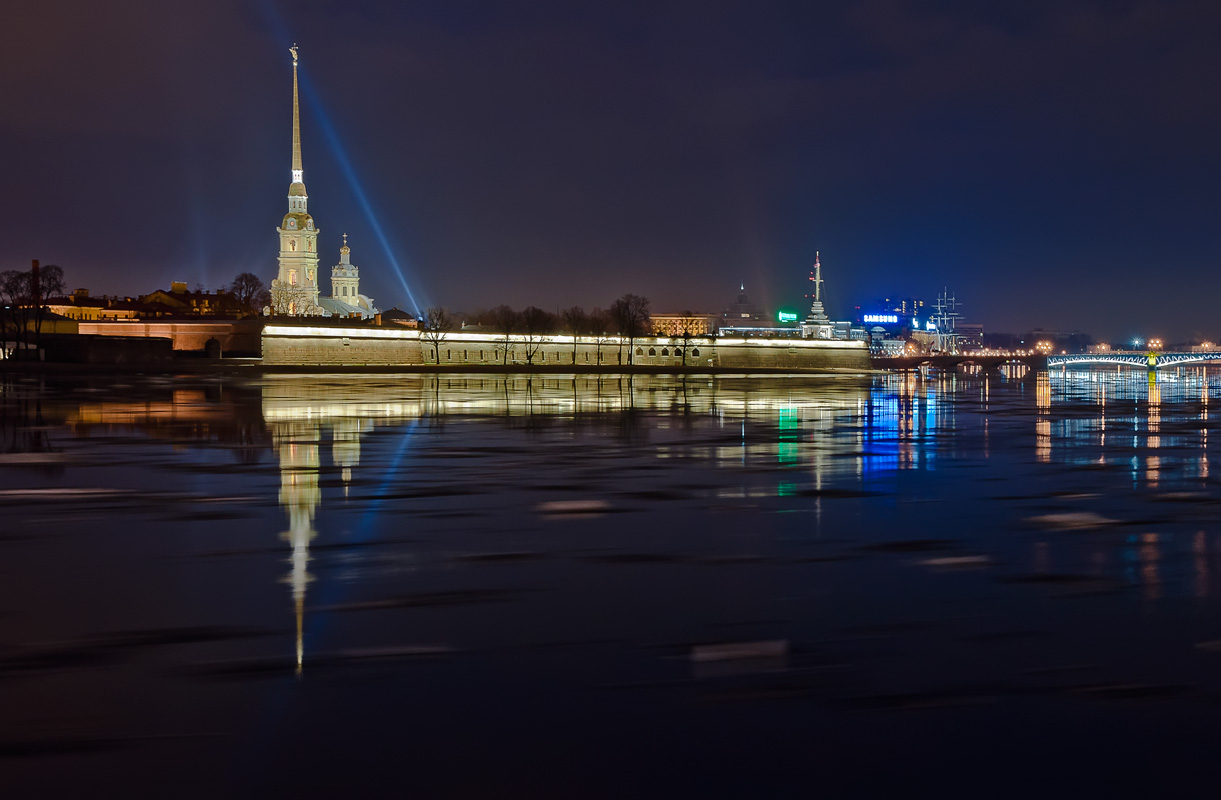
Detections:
421,294,650,364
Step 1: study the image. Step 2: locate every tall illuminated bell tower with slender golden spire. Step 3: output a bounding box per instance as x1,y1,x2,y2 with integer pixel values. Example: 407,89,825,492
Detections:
271,44,324,316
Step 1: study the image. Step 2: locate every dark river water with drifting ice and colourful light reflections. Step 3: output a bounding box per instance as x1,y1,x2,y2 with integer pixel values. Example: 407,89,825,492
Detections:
0,371,1221,798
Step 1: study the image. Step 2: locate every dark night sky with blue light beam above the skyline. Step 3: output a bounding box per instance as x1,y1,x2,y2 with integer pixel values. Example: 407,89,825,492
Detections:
7,0,1221,341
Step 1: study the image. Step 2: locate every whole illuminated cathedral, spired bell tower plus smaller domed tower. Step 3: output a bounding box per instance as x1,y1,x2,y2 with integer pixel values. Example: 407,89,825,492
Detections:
270,45,379,319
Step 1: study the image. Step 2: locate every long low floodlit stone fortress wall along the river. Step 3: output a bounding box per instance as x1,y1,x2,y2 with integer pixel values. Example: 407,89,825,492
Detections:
263,325,871,371
